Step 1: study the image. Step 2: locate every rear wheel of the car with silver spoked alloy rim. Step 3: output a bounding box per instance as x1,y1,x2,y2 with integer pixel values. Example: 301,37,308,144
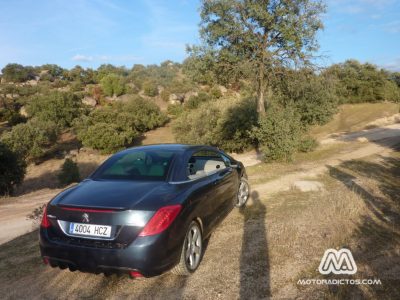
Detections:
171,221,203,276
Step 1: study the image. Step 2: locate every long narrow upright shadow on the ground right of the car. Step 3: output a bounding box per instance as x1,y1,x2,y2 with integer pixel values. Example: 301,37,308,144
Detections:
240,191,271,299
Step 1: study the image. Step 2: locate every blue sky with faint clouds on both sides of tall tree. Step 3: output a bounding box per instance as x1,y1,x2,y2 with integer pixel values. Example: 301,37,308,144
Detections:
0,0,400,70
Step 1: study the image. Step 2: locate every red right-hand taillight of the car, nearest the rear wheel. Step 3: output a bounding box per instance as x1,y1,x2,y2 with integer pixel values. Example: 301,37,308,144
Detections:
139,205,182,236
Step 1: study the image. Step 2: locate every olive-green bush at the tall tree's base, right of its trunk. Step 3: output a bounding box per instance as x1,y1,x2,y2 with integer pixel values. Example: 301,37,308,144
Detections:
252,106,304,161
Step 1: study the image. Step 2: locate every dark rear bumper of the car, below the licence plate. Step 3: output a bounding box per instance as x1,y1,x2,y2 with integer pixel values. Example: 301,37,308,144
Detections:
39,228,182,277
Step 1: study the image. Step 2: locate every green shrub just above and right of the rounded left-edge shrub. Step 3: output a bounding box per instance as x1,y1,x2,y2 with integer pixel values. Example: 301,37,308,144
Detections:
27,92,82,129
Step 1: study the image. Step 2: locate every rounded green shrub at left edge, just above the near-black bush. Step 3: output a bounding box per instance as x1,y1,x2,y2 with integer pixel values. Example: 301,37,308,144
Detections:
2,119,57,161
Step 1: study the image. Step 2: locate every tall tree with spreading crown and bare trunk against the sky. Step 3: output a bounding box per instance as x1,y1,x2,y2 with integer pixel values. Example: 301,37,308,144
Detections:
193,0,325,115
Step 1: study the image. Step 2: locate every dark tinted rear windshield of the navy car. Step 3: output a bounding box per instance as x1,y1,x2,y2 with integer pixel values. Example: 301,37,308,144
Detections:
92,150,174,180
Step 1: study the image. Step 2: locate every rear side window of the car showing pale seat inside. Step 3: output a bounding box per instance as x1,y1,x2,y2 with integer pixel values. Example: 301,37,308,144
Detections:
187,150,227,179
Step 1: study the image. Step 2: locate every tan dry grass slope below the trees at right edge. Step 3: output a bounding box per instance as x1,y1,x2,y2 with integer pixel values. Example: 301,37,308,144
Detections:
311,102,399,137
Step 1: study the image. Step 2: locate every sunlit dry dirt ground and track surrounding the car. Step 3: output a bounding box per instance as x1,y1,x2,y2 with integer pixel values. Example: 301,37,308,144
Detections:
0,119,400,299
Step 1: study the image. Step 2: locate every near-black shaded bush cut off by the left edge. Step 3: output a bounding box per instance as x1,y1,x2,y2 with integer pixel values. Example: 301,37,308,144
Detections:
0,142,26,195
